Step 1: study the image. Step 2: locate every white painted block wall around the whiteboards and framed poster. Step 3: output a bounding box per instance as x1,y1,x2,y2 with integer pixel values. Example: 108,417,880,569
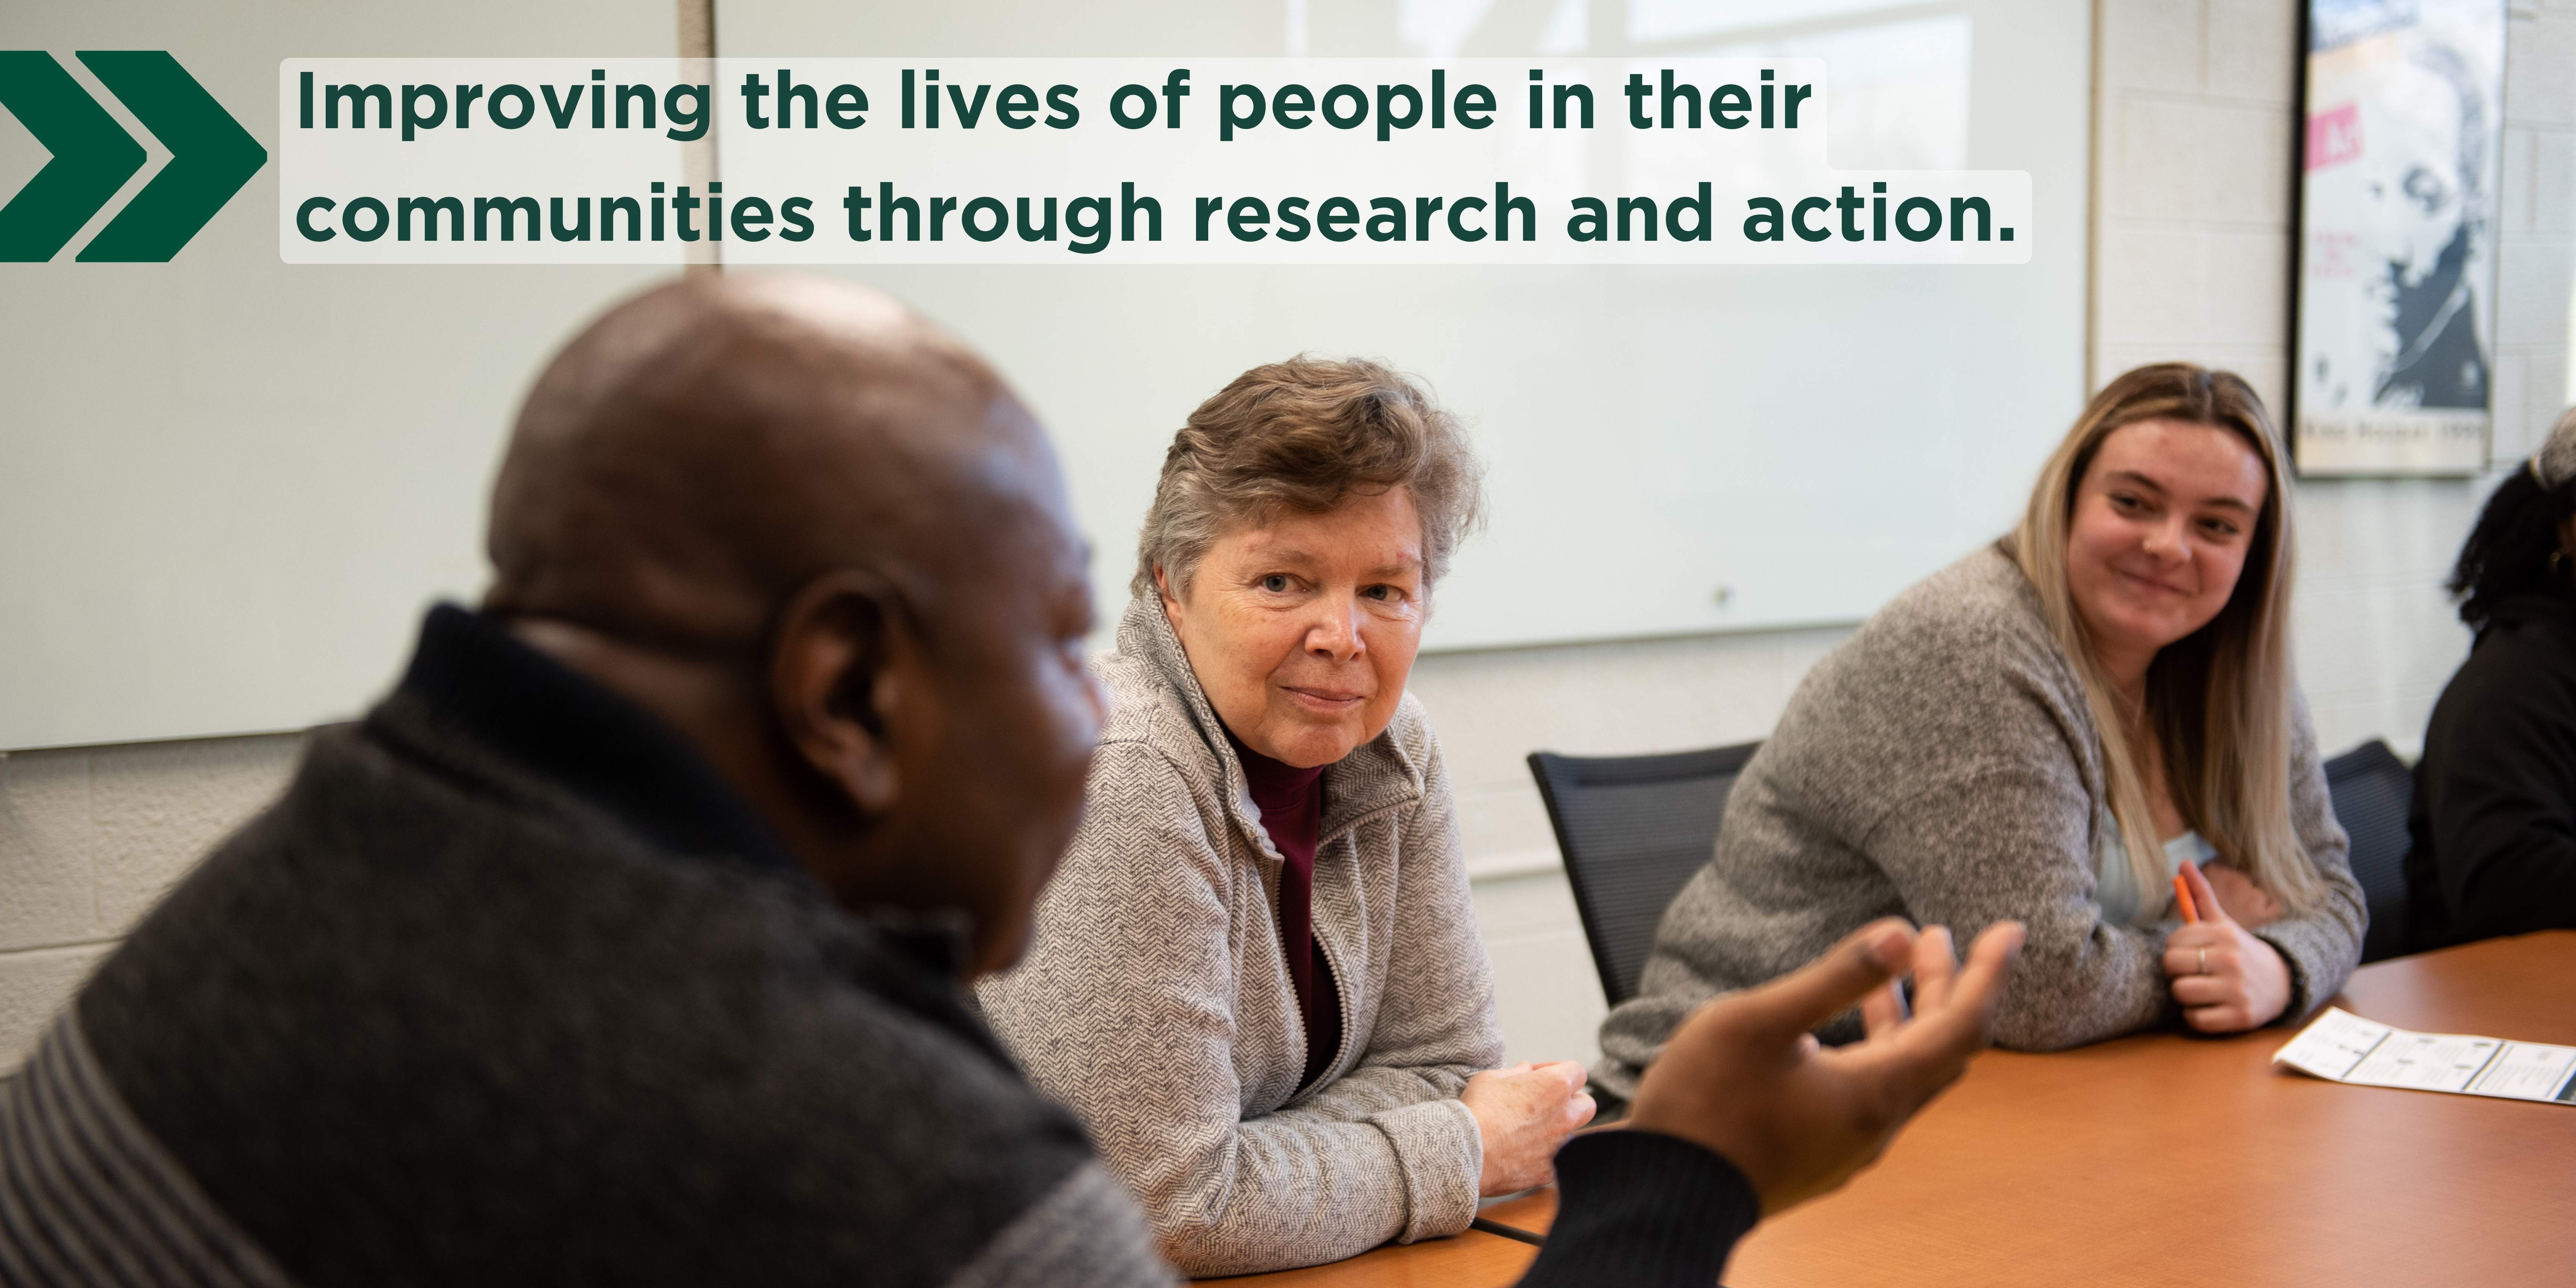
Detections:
0,0,2576,1069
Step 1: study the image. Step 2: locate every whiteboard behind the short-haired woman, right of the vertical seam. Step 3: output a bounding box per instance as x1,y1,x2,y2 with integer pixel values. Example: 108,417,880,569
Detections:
719,0,2092,649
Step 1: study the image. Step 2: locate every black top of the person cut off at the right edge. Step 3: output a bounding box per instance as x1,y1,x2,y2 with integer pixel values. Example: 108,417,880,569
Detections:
2406,595,2576,948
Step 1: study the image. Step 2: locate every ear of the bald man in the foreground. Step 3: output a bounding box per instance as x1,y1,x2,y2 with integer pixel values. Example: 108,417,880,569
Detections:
770,569,917,814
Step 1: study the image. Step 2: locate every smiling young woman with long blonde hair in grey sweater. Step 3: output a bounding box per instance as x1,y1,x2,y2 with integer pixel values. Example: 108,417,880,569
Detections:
1595,363,2362,1095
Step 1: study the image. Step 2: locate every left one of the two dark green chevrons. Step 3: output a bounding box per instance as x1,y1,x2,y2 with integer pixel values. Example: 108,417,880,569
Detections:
0,49,144,263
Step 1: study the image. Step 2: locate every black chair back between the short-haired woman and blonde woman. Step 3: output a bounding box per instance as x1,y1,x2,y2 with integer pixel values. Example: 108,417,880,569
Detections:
1530,742,1762,1007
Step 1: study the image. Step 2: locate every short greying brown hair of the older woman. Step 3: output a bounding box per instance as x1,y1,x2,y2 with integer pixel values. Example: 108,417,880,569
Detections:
1133,356,1484,595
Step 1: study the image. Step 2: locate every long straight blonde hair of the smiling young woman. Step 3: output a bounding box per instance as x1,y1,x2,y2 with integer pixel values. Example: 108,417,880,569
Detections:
2007,363,2318,907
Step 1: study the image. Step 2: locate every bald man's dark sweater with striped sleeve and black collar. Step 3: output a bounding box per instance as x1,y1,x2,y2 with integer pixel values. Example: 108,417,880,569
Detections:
0,608,1759,1288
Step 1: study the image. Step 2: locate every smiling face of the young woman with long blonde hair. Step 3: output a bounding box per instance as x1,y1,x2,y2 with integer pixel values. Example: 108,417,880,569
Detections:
2066,420,2272,675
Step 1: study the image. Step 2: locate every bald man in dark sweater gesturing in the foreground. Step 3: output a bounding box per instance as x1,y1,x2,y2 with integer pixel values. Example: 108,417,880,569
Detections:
0,278,2017,1288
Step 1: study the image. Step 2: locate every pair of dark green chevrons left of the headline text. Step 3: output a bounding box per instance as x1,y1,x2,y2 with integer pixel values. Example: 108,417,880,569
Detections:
0,49,268,263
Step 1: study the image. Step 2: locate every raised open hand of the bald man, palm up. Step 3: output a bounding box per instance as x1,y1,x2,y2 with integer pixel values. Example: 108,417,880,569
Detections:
1628,917,2022,1216
